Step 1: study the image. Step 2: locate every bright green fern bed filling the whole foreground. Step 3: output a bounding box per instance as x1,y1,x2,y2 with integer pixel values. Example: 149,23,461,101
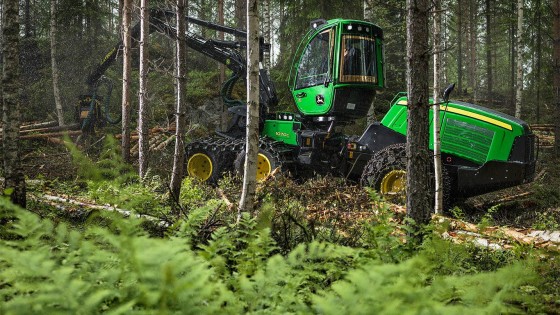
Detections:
0,199,557,314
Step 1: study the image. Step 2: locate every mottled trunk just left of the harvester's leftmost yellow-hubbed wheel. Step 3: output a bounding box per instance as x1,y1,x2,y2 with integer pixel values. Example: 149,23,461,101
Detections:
170,0,187,207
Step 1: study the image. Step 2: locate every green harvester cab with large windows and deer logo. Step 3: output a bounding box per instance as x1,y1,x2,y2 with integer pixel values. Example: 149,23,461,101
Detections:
289,19,385,125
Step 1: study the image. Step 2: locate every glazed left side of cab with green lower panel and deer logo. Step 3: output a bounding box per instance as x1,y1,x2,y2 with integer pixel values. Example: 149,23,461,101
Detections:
292,27,335,115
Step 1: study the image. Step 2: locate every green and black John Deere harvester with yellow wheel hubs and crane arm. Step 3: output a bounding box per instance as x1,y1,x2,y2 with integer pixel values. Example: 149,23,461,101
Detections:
83,10,536,207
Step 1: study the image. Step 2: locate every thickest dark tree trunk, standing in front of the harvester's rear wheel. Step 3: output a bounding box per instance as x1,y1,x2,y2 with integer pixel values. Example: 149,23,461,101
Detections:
406,0,433,224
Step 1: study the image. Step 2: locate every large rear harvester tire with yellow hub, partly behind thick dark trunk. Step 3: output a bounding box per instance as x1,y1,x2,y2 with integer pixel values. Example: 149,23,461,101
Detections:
360,143,453,210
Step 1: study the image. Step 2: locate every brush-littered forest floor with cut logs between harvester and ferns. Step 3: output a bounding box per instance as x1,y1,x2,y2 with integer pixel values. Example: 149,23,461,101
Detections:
7,135,560,314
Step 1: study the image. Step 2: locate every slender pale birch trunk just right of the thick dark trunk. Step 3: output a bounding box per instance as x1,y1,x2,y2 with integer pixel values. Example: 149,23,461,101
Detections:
432,0,443,214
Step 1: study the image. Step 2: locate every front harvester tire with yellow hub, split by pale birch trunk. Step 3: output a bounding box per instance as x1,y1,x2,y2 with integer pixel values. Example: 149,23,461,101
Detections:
233,140,282,181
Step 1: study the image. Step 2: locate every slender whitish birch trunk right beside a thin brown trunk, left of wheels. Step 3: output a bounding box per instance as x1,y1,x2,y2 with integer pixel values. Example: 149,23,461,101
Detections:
138,0,150,179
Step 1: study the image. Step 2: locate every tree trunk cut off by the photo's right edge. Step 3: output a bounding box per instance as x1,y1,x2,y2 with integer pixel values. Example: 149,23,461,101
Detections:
552,0,560,158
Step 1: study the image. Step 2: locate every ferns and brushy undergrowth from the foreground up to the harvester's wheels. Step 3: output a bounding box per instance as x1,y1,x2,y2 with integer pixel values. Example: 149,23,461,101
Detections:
7,138,560,314
